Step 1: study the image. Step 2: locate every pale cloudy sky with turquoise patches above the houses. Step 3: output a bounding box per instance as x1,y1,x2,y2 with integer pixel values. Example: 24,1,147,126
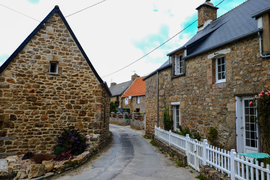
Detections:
0,0,246,86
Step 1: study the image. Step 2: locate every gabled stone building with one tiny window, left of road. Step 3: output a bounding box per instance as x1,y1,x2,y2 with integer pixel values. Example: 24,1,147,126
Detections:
0,6,111,156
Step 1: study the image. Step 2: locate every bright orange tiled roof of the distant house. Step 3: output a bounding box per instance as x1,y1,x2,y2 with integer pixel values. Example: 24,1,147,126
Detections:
122,77,145,97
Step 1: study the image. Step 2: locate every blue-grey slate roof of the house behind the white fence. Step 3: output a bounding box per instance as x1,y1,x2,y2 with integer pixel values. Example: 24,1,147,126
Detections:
145,0,270,79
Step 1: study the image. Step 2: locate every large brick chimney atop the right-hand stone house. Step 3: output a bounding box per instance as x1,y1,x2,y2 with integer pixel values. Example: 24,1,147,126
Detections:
196,0,218,28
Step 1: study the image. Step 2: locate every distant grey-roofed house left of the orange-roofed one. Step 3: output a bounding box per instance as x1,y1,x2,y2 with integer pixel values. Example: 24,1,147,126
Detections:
110,73,139,109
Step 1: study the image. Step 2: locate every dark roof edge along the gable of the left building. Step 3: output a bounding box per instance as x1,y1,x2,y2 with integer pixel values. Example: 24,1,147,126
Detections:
0,6,111,95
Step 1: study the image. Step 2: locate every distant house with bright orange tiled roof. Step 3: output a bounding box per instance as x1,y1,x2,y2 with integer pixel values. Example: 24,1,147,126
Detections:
121,77,145,113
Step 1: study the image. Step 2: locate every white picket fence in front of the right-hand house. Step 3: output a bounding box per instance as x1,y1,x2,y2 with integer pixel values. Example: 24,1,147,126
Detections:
155,127,270,180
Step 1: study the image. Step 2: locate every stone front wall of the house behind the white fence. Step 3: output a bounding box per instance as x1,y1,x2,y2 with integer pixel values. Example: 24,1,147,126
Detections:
146,35,270,149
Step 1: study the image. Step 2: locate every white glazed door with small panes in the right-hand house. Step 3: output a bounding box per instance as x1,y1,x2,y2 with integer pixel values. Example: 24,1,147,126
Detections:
242,98,258,153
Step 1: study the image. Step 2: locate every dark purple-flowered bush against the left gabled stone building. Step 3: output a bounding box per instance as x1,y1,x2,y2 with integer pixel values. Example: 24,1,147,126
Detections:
54,128,87,155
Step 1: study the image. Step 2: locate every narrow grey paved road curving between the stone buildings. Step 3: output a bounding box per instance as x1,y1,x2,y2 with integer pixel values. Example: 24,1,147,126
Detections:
55,125,198,180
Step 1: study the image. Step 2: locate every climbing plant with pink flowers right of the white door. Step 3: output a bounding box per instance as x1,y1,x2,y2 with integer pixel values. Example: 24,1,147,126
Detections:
249,91,270,152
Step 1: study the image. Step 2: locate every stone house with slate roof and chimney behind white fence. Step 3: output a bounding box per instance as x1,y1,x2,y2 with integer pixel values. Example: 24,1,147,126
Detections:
144,0,270,152
